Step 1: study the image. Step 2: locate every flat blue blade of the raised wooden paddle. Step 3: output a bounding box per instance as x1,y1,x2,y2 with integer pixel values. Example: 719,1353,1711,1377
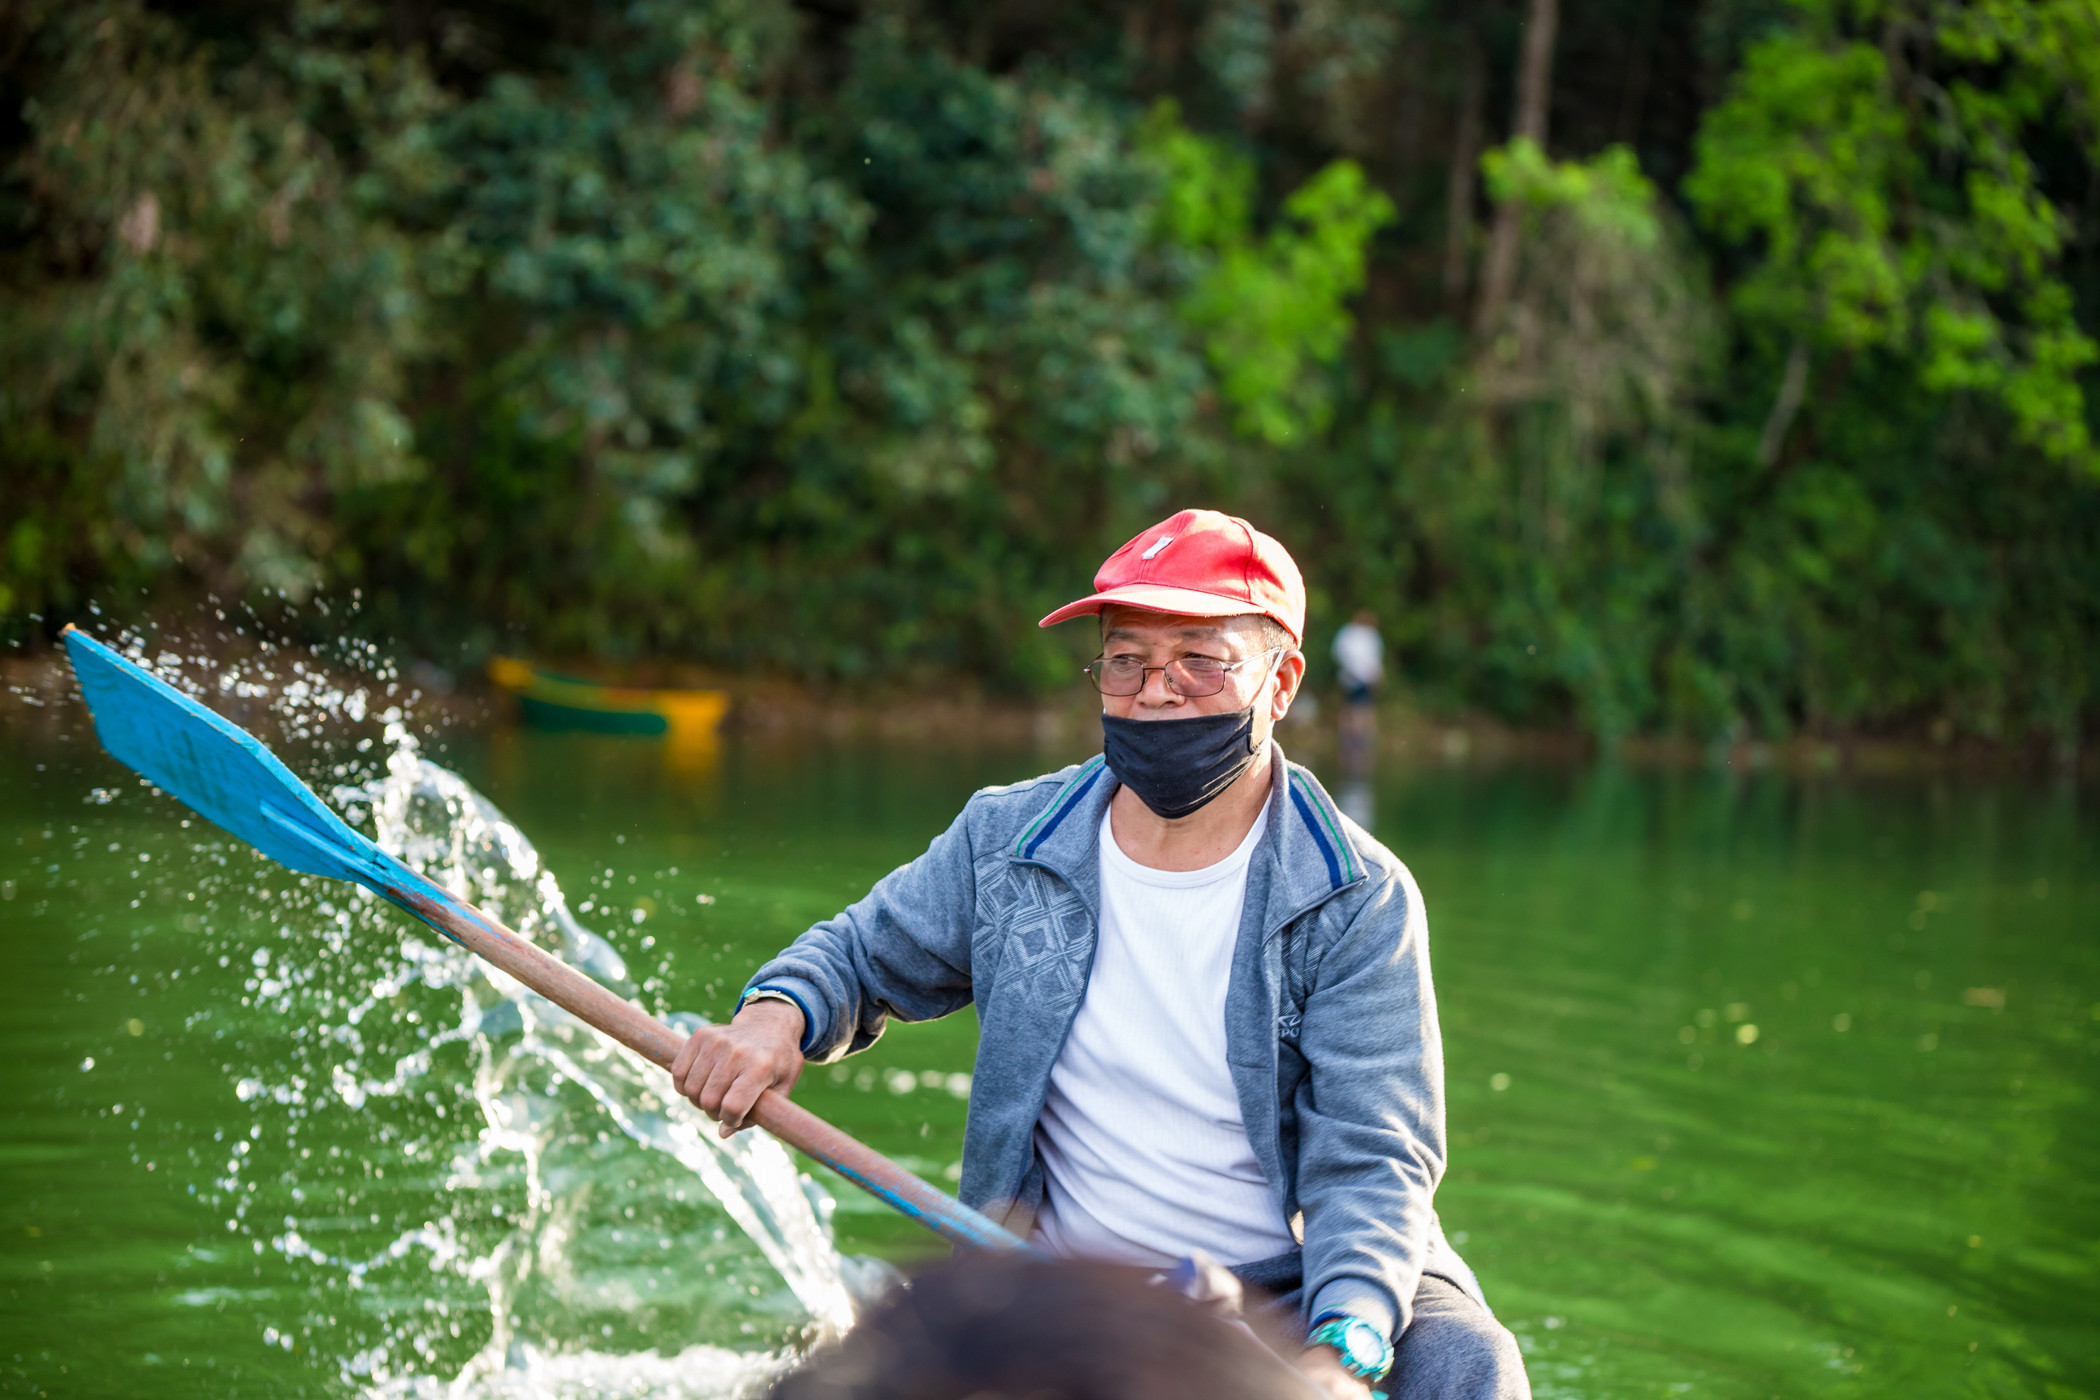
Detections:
65,628,464,938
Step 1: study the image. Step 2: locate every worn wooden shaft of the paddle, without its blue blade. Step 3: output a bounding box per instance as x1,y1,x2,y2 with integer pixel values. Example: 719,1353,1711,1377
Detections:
384,888,1029,1249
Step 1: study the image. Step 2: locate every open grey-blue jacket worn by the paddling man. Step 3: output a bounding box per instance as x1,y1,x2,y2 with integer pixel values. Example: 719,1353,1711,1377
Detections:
750,749,1478,1335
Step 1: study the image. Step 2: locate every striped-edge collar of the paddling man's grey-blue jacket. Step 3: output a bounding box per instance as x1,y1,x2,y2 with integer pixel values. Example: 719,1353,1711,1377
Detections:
1008,741,1365,930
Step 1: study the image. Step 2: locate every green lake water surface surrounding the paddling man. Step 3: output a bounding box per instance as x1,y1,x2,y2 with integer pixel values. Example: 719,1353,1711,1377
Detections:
0,705,2100,1400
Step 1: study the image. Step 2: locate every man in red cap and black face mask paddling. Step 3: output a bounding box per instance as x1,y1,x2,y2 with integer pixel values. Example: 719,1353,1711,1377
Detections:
672,510,1531,1400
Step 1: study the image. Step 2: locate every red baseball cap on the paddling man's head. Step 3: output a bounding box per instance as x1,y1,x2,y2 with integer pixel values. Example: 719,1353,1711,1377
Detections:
1035,510,1306,642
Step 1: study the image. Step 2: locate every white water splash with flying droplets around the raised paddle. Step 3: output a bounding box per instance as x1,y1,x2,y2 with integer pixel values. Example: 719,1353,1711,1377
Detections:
44,628,895,1400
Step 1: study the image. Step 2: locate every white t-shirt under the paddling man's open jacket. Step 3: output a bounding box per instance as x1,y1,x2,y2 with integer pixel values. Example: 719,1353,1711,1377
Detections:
1035,808,1296,1266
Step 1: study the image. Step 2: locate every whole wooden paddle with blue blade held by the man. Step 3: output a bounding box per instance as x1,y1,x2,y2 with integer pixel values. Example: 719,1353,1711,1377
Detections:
65,628,1031,1249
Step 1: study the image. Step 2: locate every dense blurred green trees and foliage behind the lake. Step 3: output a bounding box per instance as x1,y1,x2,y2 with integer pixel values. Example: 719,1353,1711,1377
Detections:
0,0,2100,745
